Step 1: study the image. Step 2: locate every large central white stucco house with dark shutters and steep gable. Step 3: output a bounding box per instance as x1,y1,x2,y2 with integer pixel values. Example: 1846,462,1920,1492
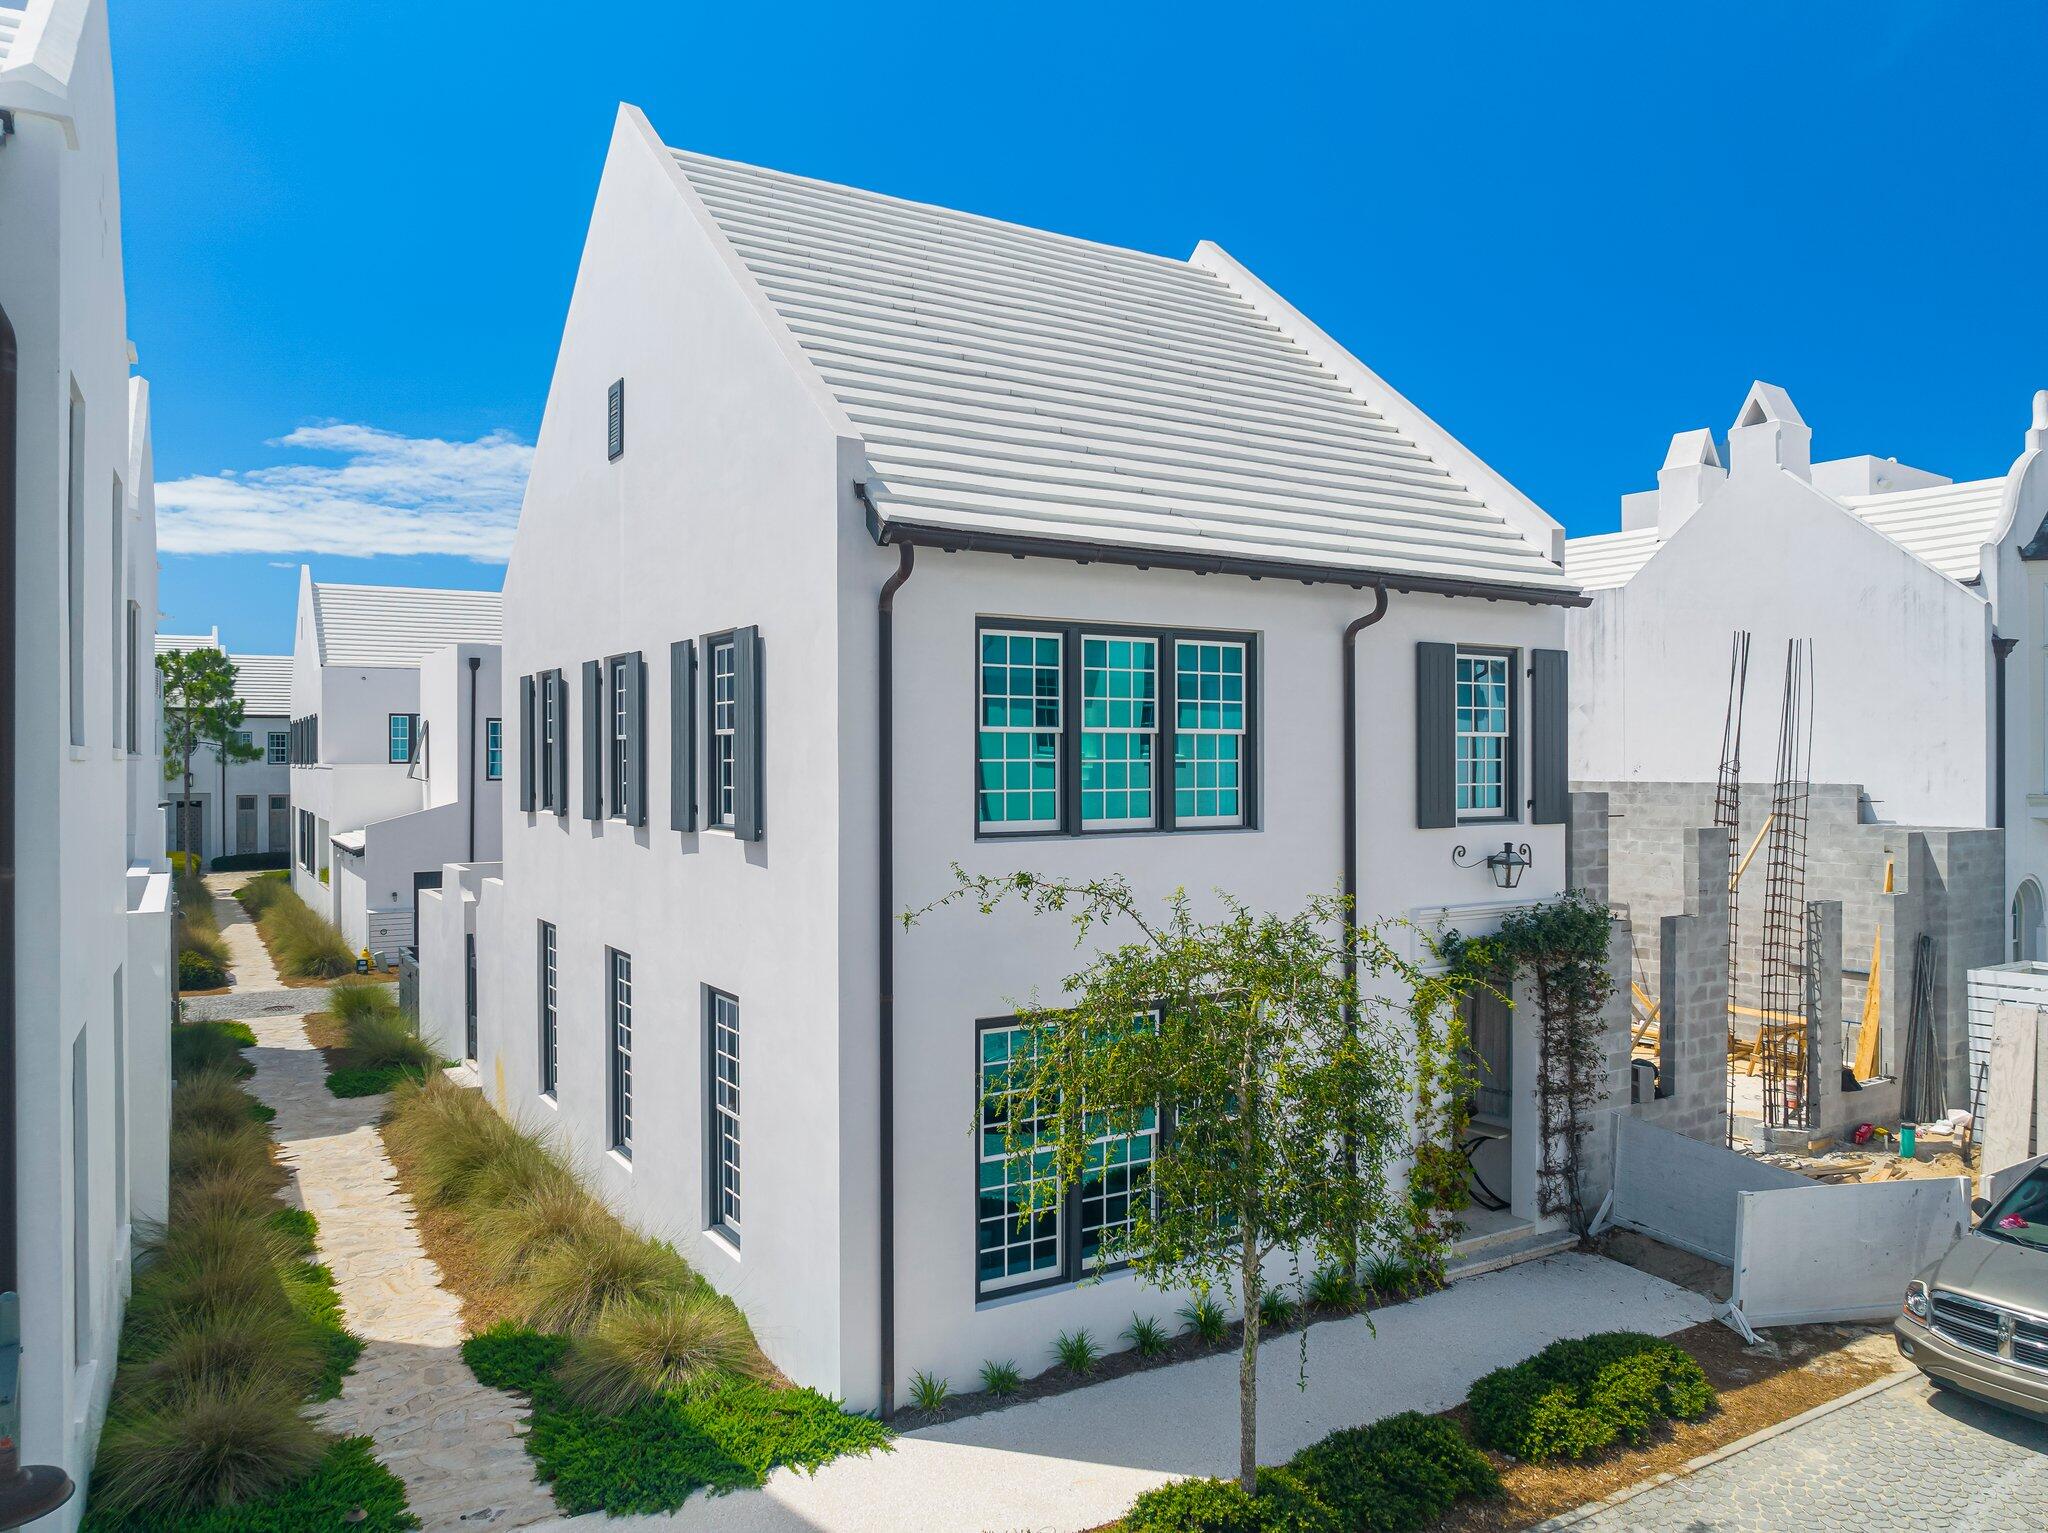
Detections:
419,106,1579,1408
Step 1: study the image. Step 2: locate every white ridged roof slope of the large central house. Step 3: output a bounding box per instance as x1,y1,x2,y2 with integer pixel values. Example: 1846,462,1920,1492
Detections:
672,149,1573,596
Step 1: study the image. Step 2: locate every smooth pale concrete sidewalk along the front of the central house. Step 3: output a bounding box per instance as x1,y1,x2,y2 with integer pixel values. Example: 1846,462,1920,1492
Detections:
532,1255,1710,1533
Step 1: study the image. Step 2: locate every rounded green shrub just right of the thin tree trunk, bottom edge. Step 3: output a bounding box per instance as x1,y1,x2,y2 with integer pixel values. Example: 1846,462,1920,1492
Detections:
1290,1410,1501,1533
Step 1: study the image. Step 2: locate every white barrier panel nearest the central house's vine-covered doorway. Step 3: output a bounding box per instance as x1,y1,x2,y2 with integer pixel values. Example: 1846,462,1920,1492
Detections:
1593,1113,1815,1267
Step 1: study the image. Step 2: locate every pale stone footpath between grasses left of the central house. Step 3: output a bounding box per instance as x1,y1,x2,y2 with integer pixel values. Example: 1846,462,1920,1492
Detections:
248,1011,555,1533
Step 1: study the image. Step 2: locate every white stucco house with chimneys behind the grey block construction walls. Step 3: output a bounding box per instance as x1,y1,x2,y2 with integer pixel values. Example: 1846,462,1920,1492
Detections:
1565,383,2048,958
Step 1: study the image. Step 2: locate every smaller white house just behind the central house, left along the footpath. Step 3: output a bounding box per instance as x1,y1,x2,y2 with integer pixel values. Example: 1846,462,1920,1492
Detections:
287,565,504,954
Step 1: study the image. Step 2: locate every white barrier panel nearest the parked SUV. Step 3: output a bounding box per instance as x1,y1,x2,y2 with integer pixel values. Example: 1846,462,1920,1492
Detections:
1722,1177,1970,1339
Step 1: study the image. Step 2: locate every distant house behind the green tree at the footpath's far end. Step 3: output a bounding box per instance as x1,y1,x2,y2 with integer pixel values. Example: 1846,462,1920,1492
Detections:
156,628,291,868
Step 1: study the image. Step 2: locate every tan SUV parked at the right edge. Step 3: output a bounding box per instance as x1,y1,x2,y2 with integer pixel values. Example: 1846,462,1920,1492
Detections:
1892,1160,2048,1418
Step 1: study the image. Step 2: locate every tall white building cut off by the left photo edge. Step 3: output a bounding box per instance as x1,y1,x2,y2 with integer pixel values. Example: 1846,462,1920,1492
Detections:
0,0,172,1529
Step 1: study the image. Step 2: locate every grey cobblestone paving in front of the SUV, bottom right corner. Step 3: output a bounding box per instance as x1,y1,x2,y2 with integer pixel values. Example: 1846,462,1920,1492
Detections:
1573,1377,2048,1533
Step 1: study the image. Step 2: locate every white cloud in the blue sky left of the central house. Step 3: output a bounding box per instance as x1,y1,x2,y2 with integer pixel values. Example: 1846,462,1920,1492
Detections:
156,422,532,563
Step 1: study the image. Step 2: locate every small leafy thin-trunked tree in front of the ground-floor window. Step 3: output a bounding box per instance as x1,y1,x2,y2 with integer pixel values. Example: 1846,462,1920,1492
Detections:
903,868,1425,1492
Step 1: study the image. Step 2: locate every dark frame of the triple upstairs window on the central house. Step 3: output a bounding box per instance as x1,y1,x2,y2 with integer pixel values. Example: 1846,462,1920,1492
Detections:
967,614,1266,841
